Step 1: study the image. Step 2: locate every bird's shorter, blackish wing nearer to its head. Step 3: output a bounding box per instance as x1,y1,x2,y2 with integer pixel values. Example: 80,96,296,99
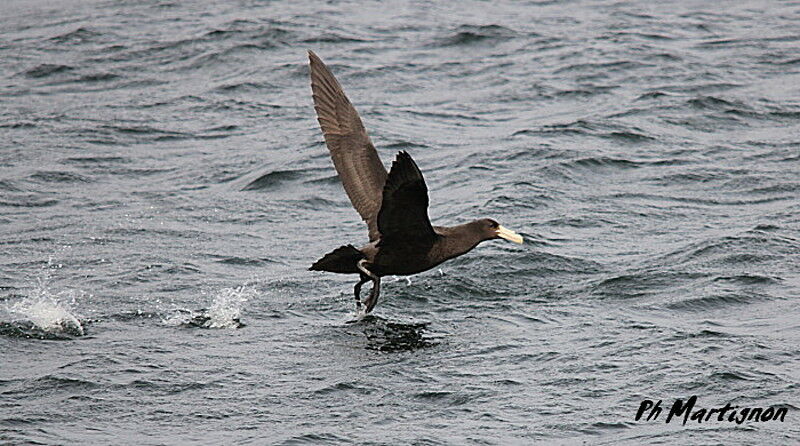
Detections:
378,152,436,243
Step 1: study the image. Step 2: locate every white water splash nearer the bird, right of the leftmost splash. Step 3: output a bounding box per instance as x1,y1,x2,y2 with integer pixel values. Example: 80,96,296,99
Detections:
163,285,255,328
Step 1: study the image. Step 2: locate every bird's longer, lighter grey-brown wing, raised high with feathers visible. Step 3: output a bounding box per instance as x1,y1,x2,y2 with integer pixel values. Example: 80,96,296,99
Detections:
308,51,386,241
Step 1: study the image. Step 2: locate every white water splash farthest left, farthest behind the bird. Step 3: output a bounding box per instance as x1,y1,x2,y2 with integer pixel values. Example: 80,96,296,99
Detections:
6,259,84,336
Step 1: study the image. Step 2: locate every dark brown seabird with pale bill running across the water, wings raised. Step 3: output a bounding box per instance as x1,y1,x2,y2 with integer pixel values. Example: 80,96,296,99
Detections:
308,51,522,313
